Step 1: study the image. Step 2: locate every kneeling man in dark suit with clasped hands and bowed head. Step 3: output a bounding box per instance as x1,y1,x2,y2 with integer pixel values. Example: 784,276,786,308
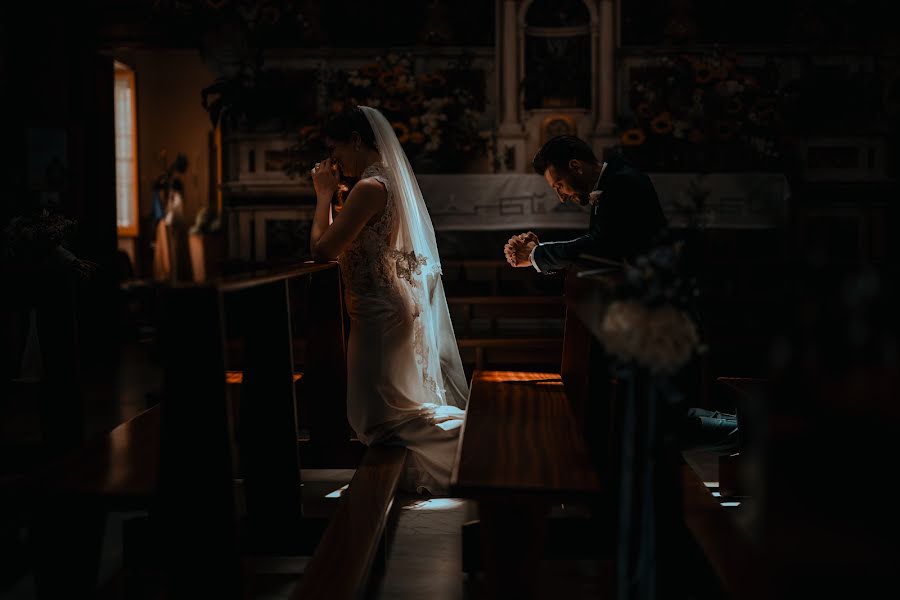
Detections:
504,135,738,454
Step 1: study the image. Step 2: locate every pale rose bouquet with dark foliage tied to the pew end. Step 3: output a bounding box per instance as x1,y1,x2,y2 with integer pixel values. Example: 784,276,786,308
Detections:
600,243,704,375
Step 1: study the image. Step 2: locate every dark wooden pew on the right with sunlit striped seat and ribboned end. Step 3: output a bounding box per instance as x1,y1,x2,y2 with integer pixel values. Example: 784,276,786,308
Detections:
453,271,762,598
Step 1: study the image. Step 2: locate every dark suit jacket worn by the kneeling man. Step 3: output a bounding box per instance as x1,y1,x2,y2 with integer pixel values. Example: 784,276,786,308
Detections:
534,157,668,273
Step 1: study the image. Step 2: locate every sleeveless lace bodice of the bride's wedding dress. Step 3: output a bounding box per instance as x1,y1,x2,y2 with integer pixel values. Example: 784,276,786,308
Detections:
338,162,396,302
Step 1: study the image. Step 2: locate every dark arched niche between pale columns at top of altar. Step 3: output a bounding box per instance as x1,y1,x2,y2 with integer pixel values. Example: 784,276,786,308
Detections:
524,0,591,109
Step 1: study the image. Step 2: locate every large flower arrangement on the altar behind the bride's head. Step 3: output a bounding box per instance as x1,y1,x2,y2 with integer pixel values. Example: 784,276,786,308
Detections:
286,53,487,175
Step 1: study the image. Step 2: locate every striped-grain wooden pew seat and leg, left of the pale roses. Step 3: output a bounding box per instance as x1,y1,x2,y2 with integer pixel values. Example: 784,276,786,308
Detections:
451,270,609,597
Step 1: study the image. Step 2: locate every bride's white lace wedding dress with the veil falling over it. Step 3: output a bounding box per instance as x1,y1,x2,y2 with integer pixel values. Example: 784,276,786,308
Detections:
338,156,467,495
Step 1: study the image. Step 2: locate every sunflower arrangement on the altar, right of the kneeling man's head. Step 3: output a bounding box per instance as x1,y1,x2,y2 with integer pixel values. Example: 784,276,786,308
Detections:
619,52,782,171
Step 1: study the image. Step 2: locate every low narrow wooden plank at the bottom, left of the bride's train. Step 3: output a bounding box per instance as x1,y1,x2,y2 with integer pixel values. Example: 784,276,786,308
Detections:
291,446,407,600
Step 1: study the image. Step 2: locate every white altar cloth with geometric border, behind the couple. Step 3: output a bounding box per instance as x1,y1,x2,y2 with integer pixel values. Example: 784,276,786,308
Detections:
417,173,790,231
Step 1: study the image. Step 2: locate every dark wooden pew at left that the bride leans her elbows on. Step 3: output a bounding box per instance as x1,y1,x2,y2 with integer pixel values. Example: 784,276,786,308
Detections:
23,264,349,598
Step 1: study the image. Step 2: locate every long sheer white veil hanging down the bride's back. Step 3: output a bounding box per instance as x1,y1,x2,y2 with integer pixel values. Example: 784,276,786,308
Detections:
360,106,468,408
